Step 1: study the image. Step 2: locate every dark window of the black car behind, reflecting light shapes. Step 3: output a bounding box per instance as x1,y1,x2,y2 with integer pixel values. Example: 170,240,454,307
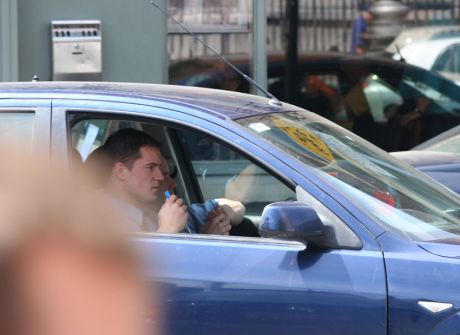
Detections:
294,67,460,151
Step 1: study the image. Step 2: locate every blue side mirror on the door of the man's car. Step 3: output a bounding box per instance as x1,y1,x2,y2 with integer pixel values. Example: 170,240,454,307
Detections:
259,201,323,241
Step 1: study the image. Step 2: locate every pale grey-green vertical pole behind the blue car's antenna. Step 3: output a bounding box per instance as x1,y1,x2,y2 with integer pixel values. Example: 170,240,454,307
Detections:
252,0,267,96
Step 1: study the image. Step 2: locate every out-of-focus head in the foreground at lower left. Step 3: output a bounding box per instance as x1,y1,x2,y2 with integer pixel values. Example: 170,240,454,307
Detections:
0,149,157,335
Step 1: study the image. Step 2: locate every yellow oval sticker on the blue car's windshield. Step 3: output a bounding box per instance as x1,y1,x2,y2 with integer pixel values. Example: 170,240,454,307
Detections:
272,118,335,162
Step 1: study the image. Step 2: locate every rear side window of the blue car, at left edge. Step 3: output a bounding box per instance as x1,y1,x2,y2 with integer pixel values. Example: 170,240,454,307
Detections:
0,112,34,149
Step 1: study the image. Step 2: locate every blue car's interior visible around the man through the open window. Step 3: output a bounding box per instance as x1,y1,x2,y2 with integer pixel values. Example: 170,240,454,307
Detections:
71,117,296,236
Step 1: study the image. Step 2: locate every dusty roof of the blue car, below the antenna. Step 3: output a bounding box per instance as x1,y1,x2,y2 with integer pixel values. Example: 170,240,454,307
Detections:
0,82,282,119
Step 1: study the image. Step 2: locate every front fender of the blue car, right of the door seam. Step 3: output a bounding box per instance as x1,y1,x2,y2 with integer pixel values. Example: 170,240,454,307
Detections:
378,233,460,334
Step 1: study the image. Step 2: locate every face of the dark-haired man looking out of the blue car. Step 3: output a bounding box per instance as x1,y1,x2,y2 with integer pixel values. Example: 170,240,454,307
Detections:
123,146,164,206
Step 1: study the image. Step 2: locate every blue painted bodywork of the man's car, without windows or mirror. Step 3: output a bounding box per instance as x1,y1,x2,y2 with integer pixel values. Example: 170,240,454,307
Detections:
0,83,460,335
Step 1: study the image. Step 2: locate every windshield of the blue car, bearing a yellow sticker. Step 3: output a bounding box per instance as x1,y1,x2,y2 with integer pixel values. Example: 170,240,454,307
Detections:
237,110,460,241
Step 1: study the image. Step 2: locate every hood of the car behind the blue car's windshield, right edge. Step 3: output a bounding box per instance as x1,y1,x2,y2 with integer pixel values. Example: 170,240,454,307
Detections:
391,150,460,168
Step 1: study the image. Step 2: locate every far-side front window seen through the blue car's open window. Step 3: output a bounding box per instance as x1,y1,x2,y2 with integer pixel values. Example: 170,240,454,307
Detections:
177,130,296,223
